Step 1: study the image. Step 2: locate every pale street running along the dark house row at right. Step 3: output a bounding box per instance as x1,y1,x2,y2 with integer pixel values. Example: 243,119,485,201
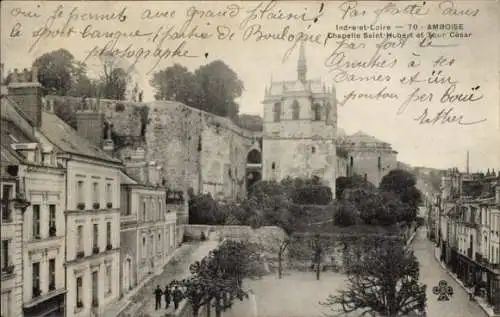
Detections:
413,228,487,317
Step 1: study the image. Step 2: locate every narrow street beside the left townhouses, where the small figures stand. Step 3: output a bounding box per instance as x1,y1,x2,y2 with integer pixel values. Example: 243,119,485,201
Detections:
101,240,219,317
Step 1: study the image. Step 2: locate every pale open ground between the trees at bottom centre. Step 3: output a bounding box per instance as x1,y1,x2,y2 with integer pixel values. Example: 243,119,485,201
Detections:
224,272,354,317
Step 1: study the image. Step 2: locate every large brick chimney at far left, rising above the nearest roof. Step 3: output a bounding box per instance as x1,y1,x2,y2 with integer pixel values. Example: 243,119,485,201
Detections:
7,67,43,127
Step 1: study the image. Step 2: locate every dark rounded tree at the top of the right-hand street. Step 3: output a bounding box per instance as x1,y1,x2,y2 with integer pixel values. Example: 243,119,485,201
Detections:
379,169,422,222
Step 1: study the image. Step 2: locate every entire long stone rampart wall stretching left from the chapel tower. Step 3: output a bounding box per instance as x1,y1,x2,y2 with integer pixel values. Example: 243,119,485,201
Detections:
47,96,260,198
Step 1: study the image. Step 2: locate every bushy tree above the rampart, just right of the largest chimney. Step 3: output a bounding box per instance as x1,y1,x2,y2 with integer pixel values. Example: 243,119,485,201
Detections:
33,49,87,96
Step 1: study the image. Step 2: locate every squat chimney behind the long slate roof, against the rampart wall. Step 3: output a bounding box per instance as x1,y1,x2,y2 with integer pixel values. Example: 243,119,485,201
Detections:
75,97,104,148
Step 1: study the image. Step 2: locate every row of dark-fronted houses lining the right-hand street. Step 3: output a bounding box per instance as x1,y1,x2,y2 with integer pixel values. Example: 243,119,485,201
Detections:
439,169,500,312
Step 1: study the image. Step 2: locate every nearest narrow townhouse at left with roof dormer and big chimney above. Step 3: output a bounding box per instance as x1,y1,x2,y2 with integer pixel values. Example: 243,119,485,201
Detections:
1,69,66,316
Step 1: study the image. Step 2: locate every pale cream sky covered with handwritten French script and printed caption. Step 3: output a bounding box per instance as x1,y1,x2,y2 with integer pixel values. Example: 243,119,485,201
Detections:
1,1,500,171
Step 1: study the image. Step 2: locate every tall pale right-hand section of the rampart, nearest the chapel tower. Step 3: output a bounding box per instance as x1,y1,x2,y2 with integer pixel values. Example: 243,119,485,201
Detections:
145,102,253,198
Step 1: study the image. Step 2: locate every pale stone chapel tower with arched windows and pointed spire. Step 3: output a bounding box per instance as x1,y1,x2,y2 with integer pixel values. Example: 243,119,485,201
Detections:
262,43,337,193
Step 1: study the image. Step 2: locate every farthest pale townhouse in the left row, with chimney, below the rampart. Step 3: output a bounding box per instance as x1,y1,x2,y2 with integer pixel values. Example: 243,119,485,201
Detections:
120,148,177,294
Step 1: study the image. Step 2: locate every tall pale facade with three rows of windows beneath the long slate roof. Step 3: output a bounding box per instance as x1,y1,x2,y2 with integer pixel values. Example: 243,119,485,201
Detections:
66,157,120,316
